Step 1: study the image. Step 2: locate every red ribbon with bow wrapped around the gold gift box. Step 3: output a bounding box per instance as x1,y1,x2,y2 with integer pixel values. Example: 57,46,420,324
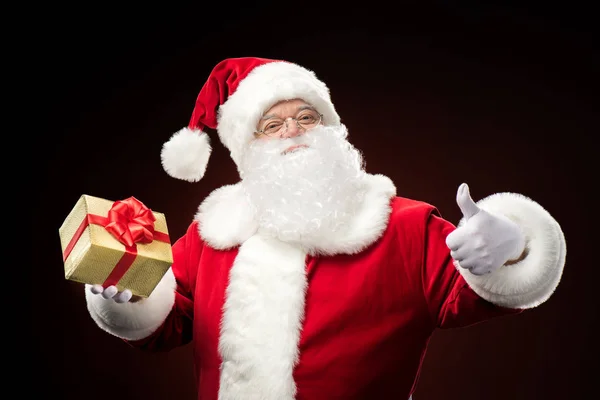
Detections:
63,197,170,287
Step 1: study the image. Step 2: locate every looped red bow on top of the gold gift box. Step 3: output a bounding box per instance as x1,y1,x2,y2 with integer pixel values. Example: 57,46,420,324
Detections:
105,197,156,247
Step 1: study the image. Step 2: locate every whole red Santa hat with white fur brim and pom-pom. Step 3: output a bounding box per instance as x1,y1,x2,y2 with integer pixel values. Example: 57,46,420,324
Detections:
161,57,340,182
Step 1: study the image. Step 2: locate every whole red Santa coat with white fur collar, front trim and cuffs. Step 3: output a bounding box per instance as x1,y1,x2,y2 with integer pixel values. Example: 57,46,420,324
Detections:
88,176,565,400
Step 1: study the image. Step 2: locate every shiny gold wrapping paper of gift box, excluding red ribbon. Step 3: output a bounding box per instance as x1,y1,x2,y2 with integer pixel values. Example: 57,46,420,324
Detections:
59,195,173,297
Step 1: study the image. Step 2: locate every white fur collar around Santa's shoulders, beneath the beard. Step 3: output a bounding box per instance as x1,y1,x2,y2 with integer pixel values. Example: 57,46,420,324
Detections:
194,174,396,255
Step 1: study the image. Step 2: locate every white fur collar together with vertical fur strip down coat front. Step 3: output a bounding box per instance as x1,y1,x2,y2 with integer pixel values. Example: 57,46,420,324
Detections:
195,174,396,400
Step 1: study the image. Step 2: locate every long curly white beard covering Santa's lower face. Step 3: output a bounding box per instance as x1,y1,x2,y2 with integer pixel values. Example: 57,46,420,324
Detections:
240,125,366,244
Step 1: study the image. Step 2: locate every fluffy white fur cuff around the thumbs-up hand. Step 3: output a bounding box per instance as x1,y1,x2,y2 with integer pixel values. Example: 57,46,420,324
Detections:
457,193,566,309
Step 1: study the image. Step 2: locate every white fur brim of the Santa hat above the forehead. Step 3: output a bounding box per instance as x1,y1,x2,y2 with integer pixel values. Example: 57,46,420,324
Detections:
217,61,340,166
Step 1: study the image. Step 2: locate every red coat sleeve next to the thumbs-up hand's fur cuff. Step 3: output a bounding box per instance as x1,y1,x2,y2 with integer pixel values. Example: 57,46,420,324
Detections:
422,209,521,329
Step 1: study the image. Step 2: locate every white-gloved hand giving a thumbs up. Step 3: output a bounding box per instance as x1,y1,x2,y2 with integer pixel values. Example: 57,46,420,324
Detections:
446,183,525,275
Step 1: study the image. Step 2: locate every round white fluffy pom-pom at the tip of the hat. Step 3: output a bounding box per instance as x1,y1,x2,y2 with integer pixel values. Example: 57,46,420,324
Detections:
160,128,212,182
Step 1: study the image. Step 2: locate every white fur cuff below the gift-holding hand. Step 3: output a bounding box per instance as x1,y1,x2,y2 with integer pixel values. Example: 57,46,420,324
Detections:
85,269,176,340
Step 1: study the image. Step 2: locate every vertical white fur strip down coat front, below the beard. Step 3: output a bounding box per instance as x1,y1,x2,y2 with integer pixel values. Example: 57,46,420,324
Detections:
219,234,307,400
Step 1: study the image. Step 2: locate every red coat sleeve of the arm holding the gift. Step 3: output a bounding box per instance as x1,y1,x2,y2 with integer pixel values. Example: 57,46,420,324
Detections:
128,222,203,351
